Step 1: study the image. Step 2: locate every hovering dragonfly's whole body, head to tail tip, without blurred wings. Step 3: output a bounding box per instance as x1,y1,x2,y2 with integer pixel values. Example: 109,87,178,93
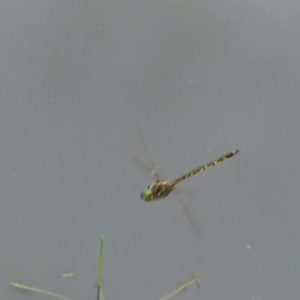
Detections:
140,149,239,202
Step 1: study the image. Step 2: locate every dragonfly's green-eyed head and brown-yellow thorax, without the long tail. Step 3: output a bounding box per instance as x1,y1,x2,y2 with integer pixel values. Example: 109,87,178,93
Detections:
141,180,174,201
